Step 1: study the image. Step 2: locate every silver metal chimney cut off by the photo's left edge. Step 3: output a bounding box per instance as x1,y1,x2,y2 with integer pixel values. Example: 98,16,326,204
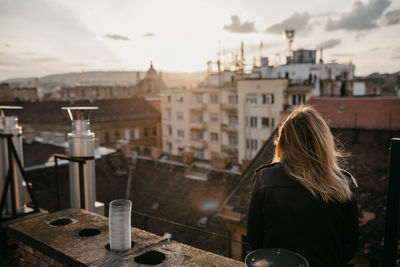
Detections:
0,106,25,214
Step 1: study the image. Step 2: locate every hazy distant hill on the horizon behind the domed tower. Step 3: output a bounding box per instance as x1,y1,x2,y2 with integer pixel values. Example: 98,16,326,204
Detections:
2,71,207,91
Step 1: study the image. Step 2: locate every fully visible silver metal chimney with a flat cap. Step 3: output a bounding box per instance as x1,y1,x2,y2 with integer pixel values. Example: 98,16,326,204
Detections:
62,107,97,212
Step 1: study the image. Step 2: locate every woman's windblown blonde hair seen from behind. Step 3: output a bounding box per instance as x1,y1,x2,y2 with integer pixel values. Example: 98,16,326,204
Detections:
273,106,357,203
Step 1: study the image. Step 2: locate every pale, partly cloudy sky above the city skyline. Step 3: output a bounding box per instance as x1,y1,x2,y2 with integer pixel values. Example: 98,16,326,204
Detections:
0,0,400,80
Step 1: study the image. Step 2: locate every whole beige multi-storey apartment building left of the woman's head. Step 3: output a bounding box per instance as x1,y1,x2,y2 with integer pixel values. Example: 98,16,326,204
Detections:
161,72,313,163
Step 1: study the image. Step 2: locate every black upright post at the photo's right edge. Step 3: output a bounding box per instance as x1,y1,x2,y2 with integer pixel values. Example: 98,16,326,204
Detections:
383,138,400,267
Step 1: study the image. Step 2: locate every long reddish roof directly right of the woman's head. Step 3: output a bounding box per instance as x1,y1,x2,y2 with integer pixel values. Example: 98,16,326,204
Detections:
309,97,400,129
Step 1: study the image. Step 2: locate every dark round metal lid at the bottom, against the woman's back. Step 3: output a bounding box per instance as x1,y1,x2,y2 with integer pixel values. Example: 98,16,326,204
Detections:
245,248,309,267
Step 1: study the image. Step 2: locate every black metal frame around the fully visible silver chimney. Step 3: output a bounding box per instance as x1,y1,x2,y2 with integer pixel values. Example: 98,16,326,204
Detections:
52,154,94,213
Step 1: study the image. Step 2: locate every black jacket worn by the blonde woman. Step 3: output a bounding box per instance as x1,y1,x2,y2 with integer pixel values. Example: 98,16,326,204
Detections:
247,163,358,267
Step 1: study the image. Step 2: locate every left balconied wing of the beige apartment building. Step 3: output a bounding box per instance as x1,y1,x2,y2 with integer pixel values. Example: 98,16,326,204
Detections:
161,88,221,159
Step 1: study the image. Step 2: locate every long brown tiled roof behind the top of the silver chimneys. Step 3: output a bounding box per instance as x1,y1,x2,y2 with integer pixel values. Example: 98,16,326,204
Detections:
5,98,161,124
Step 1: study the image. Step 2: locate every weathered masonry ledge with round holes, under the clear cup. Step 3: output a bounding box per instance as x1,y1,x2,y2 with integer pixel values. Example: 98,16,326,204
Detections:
8,210,245,267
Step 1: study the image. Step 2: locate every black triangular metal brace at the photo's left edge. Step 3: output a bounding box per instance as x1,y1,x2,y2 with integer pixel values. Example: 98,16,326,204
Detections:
0,134,40,222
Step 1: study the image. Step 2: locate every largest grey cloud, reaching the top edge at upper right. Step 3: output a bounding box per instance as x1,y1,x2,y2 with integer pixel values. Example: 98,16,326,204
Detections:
326,0,390,31
